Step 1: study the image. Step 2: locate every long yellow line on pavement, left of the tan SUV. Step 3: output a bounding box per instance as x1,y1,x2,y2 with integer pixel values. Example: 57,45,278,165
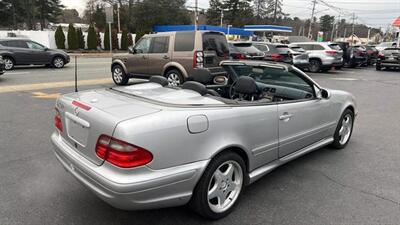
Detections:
0,78,112,93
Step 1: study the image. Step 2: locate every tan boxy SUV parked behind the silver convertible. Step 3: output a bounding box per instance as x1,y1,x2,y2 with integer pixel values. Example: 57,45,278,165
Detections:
111,31,229,86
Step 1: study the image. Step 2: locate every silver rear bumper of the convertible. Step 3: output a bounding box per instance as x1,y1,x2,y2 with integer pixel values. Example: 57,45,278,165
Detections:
51,132,209,210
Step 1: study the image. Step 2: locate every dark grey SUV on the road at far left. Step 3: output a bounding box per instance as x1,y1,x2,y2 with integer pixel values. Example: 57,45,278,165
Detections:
0,38,70,70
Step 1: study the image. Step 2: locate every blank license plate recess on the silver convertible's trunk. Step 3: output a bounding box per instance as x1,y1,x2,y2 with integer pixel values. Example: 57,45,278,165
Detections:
66,112,90,147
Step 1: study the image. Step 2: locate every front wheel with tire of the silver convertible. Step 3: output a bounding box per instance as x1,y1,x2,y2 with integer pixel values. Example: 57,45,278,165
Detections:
332,109,354,149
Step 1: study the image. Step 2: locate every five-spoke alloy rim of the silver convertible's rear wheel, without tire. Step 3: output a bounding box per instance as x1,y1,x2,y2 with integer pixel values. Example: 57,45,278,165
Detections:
207,161,243,213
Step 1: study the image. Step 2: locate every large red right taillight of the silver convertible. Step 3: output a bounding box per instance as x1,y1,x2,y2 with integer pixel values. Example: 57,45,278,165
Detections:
96,135,153,168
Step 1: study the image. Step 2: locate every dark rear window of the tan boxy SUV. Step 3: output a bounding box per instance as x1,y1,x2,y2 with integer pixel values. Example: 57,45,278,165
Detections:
203,33,229,57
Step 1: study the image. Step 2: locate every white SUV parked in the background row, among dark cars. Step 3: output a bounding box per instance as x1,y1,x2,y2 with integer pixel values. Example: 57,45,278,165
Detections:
289,42,343,73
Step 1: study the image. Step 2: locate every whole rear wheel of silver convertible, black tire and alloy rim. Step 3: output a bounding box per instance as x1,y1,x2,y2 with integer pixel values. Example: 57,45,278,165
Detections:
190,152,246,220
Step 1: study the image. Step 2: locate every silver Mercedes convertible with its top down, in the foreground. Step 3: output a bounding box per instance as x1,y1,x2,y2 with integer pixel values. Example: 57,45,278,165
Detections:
51,61,357,219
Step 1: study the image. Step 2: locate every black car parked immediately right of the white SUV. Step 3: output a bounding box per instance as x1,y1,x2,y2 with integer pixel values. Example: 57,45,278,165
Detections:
338,42,368,68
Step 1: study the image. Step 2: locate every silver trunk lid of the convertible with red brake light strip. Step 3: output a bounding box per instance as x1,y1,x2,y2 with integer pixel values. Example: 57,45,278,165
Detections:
57,90,160,165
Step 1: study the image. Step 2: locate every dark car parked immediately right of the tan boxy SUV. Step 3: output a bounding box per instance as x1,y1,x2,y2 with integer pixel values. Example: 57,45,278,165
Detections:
229,42,265,60
